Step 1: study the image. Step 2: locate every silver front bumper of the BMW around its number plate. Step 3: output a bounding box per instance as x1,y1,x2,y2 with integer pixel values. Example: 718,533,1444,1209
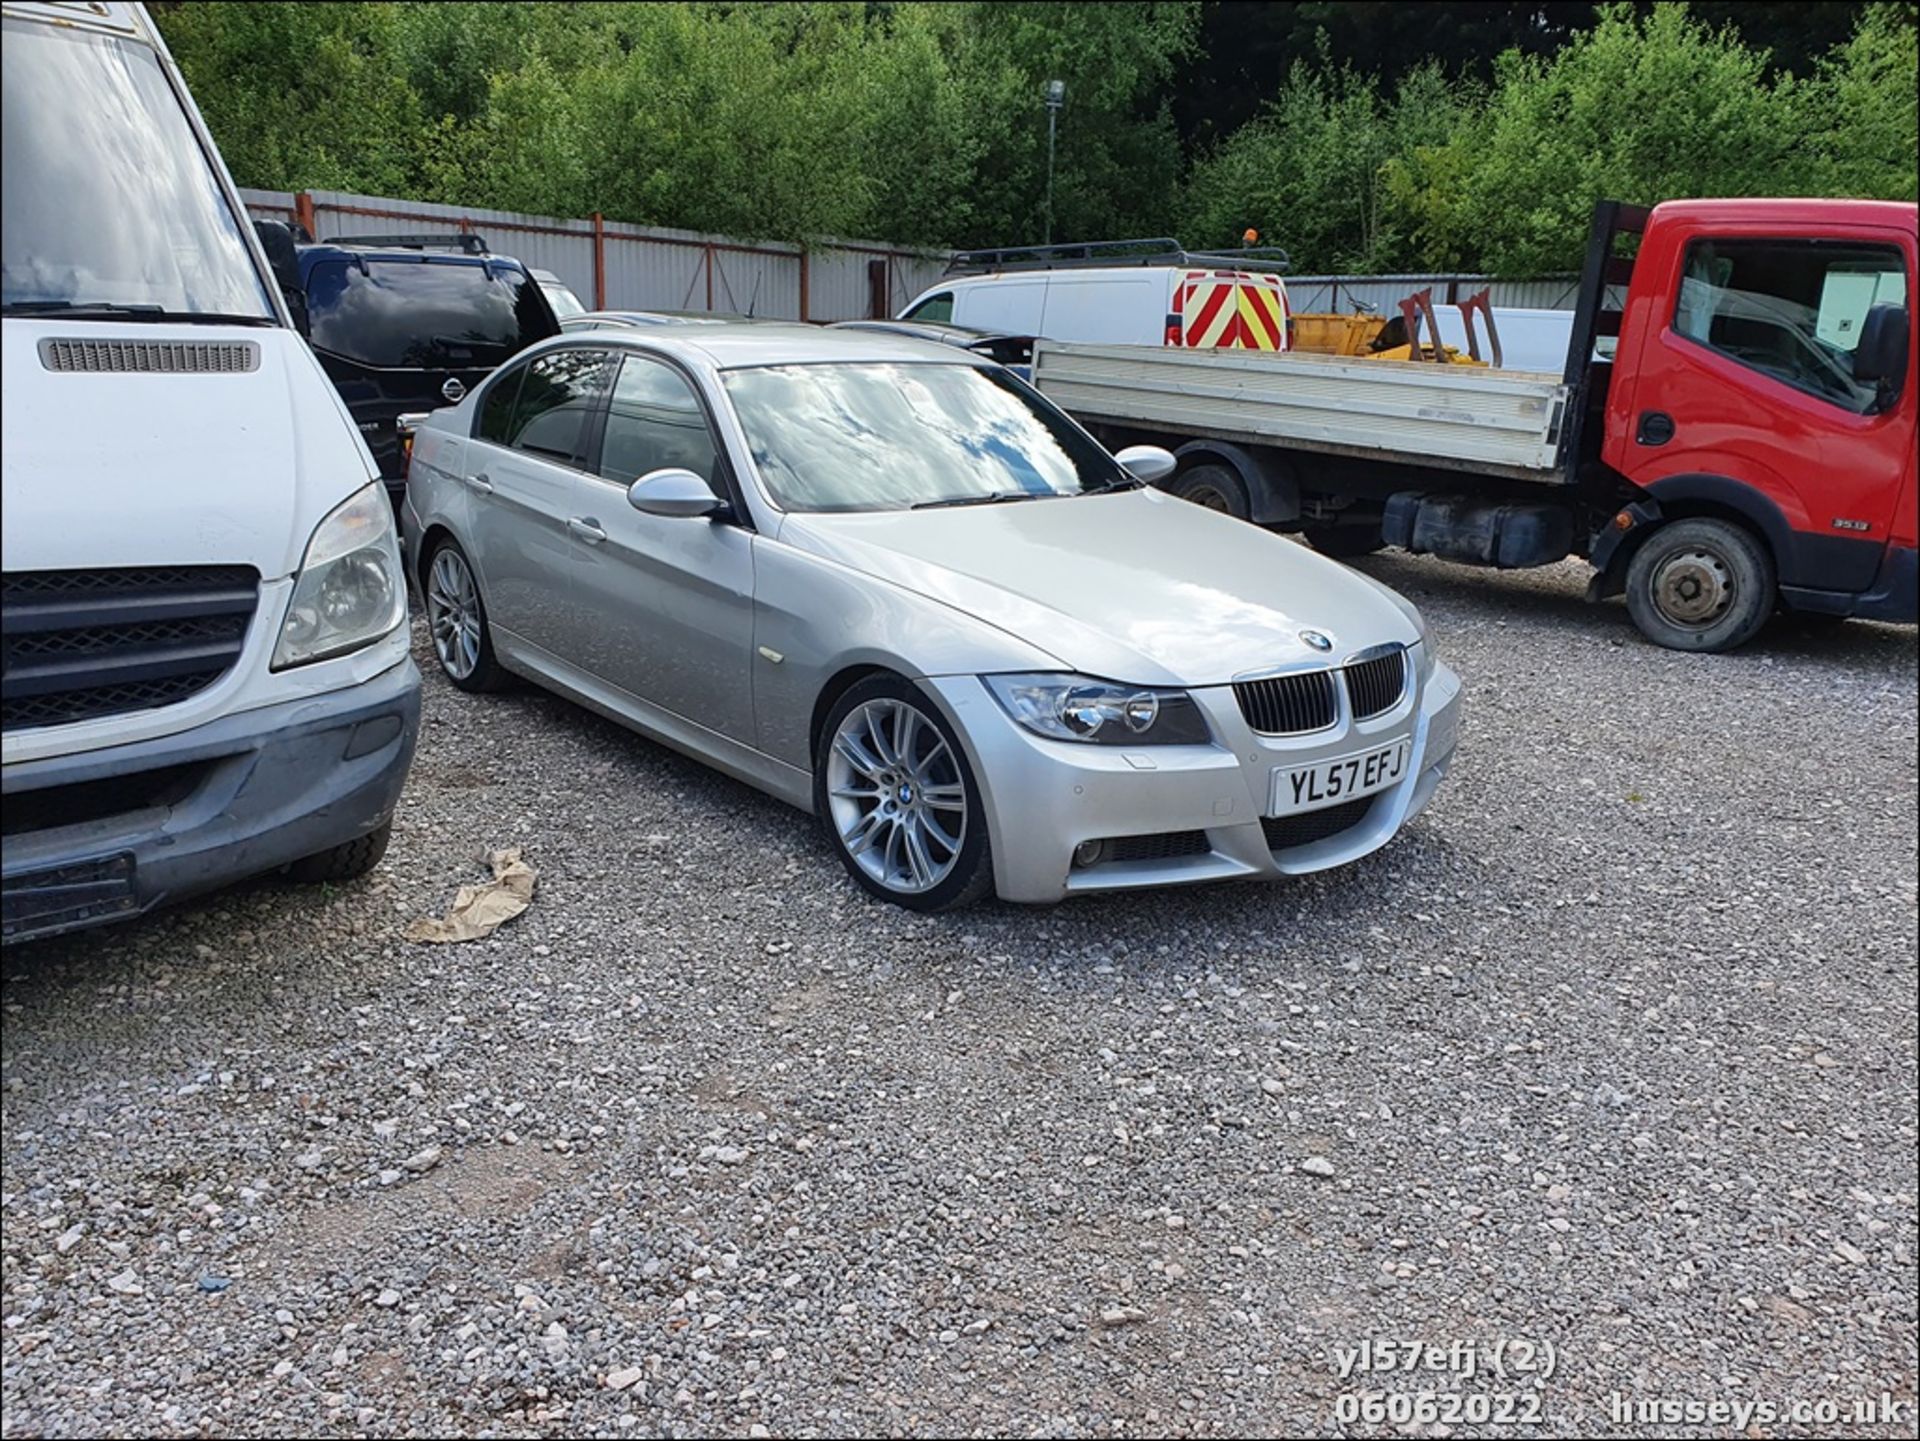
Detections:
925,664,1461,904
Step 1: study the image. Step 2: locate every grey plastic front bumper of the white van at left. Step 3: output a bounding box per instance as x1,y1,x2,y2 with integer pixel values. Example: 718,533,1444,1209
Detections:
0,658,420,942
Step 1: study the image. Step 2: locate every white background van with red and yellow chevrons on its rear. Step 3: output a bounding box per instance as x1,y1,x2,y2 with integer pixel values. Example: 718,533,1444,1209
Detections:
899,246,1292,351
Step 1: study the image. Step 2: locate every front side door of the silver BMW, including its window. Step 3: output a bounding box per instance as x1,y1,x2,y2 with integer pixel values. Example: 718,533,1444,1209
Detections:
572,355,753,744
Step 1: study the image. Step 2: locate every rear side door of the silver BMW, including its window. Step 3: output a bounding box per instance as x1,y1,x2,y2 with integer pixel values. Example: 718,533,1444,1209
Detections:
465,349,611,656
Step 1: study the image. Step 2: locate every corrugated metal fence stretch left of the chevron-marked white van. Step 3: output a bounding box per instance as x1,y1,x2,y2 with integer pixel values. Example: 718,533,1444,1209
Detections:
240,190,947,320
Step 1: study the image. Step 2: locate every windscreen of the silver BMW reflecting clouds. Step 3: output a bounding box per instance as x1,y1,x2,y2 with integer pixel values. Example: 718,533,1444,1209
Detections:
724,363,1131,510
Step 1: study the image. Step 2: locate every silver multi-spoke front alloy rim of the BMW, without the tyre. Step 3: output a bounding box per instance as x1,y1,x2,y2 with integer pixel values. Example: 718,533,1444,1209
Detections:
828,698,968,894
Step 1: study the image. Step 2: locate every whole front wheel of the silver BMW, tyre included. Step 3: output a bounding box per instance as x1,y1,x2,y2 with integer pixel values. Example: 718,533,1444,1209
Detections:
814,675,993,911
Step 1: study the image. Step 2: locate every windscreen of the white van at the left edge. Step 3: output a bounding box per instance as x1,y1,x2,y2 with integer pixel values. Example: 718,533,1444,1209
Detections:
0,19,273,320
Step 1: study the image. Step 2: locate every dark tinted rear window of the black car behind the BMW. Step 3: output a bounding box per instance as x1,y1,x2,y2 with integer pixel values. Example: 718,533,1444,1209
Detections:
307,259,557,370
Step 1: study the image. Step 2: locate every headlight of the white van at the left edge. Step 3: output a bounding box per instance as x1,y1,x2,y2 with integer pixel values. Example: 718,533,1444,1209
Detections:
273,482,407,670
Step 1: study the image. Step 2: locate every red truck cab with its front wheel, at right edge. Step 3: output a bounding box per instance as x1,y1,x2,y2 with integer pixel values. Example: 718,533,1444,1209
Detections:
1569,200,1920,650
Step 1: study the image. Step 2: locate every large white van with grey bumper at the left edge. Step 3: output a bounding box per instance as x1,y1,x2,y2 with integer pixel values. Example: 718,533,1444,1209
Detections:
0,0,420,940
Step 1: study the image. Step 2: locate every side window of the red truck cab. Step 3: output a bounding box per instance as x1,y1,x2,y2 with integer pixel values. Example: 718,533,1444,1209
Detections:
1674,240,1907,414
